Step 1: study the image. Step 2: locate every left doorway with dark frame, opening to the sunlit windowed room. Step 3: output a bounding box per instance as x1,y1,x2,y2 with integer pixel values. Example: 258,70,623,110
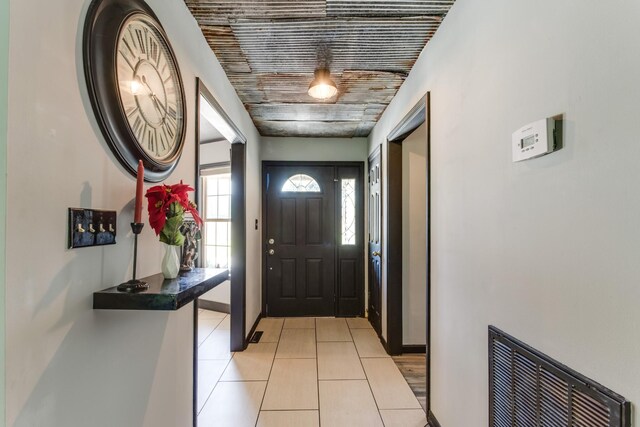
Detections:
193,79,247,426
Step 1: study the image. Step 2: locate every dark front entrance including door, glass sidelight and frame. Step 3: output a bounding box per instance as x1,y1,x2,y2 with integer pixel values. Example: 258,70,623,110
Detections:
262,162,364,317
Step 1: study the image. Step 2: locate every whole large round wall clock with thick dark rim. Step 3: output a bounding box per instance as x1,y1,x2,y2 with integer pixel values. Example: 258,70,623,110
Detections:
83,0,186,182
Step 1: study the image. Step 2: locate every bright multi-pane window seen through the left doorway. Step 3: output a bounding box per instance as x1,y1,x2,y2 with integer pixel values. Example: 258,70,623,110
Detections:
202,168,231,269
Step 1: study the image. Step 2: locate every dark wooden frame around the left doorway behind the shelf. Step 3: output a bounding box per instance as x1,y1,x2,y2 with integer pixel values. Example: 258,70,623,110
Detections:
192,77,247,427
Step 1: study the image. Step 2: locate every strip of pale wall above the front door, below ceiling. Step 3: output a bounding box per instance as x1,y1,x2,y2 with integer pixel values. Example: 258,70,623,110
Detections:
262,137,367,162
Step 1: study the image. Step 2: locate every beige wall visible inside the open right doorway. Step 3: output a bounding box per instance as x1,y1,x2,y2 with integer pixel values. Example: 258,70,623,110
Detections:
402,124,427,345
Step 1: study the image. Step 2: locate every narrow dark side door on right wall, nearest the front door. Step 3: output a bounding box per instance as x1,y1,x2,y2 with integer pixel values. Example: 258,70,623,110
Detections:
369,149,382,335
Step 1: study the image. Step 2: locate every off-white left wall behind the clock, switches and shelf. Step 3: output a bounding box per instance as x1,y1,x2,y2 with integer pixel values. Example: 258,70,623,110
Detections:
3,0,260,427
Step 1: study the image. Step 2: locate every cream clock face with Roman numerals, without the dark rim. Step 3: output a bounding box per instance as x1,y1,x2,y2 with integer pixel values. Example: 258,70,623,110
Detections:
115,14,184,162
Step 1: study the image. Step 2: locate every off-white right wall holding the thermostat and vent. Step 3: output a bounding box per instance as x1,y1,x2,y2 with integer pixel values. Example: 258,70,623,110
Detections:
369,0,640,427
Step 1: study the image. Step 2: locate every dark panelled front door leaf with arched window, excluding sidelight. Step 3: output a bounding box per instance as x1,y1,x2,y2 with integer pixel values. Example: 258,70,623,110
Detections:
265,166,335,316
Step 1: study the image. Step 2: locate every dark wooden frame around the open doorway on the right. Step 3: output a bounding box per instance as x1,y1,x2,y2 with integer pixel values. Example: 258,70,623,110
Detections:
383,92,432,414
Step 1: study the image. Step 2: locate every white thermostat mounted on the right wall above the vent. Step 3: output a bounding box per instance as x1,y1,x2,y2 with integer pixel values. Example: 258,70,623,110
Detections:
512,117,559,162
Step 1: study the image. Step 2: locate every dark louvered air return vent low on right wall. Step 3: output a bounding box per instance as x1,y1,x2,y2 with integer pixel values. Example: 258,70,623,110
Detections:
489,326,631,427
